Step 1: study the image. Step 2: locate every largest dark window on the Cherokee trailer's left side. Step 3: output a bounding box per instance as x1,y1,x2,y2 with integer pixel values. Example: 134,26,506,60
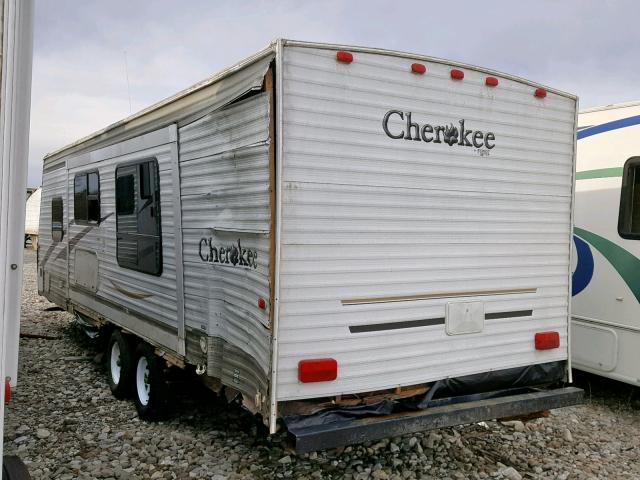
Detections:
116,159,162,275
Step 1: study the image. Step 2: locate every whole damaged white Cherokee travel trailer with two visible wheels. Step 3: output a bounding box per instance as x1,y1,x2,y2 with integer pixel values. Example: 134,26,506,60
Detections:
38,40,581,451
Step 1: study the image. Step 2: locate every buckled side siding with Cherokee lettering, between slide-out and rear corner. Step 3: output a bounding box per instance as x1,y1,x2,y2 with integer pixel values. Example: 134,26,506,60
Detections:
179,93,271,400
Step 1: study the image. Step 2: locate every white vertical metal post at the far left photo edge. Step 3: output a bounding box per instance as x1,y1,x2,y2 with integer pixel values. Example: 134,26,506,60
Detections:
0,0,33,458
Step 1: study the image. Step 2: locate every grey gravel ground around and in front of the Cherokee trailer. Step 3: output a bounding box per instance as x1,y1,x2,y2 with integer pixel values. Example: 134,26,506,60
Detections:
5,251,640,480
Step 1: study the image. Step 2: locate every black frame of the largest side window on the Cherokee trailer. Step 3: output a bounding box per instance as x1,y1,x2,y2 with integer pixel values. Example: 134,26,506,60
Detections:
114,157,164,277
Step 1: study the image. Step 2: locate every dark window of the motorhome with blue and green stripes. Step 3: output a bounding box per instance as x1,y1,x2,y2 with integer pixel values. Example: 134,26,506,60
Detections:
618,157,640,240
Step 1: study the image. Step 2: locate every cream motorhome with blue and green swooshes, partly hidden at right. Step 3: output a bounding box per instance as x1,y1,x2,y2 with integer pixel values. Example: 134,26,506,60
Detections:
572,102,640,385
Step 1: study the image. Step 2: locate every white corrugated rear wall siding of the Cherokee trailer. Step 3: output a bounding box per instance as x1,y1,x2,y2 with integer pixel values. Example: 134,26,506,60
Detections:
277,47,576,400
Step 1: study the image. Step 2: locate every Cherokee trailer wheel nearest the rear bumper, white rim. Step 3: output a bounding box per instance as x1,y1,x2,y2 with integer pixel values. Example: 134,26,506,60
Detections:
134,343,169,420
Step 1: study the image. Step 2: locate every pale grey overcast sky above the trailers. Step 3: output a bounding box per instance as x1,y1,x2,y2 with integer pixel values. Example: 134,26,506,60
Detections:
28,0,640,186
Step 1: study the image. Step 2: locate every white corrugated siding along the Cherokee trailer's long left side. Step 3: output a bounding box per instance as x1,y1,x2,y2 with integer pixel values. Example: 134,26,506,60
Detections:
42,49,273,383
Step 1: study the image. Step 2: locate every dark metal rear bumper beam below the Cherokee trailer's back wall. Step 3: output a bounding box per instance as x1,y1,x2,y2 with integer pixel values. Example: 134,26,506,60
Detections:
291,387,584,453
